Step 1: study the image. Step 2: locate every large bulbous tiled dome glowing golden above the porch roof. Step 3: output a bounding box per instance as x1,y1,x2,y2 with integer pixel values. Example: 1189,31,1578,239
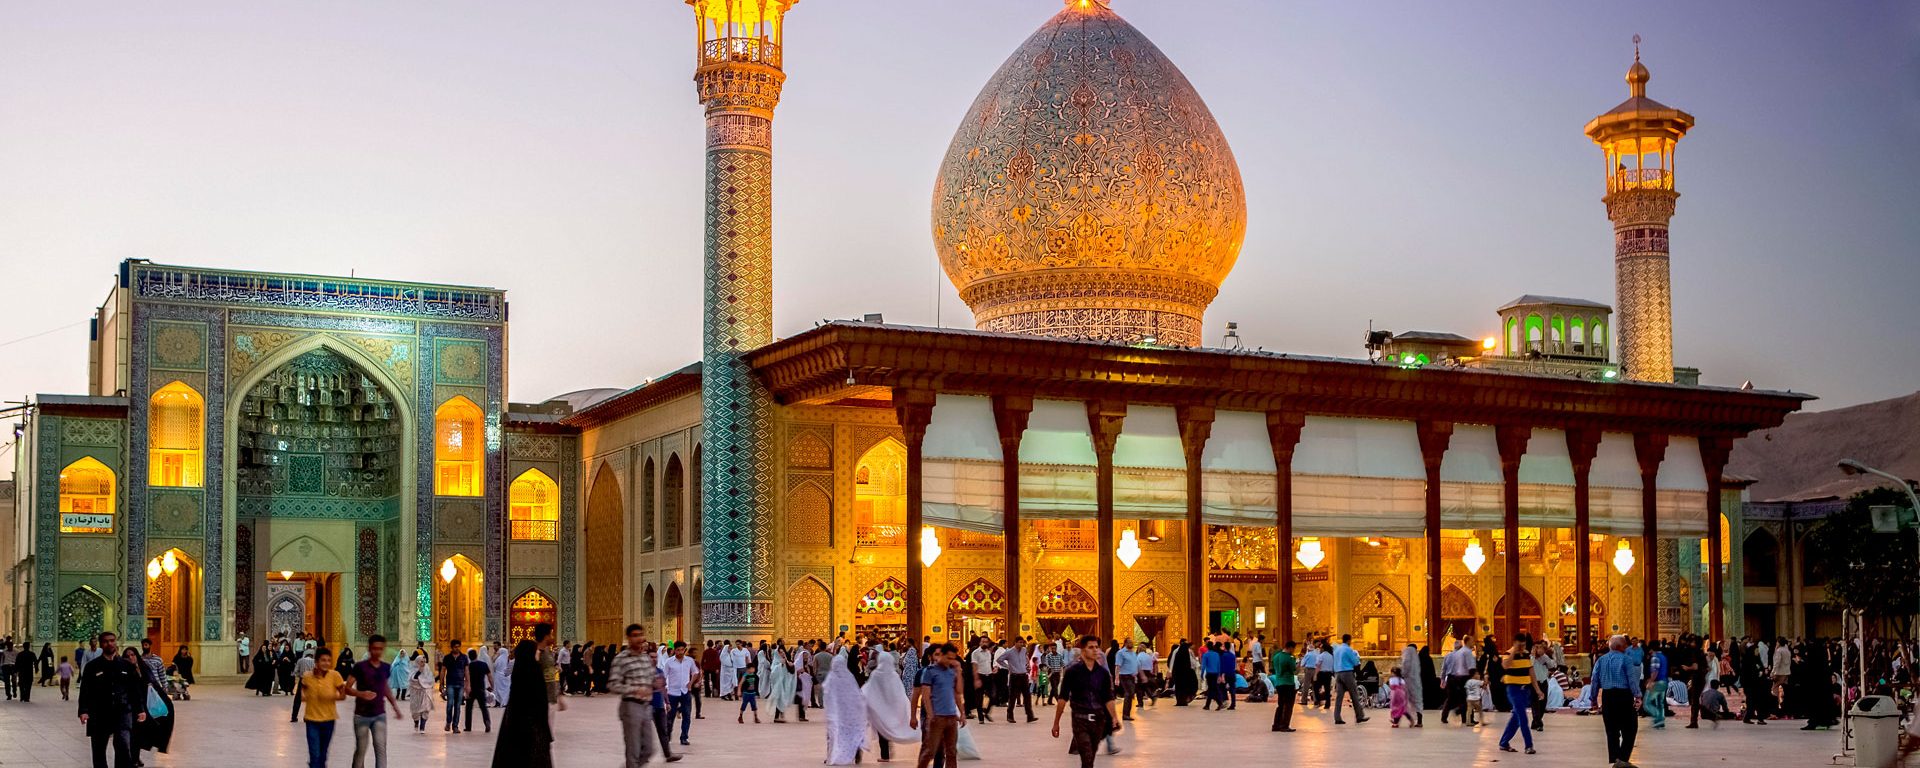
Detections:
933,0,1246,346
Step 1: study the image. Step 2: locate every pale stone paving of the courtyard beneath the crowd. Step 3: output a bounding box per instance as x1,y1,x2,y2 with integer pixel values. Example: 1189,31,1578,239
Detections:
0,684,1851,768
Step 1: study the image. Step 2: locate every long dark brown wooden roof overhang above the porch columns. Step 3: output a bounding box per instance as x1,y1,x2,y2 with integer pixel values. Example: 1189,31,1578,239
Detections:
747,321,1814,438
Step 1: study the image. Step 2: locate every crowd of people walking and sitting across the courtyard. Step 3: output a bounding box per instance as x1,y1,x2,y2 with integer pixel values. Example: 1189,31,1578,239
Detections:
11,624,1914,768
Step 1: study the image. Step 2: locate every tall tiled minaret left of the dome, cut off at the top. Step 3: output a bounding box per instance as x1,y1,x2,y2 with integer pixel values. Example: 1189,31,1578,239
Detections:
687,0,799,636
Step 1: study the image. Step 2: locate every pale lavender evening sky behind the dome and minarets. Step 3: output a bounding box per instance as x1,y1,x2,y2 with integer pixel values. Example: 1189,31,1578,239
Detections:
0,0,1920,414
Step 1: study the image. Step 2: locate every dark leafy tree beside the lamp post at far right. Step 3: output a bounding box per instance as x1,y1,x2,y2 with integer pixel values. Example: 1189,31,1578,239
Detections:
1807,488,1920,637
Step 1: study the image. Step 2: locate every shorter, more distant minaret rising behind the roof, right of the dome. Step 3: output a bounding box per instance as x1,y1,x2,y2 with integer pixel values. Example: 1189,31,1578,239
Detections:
1586,35,1693,382
